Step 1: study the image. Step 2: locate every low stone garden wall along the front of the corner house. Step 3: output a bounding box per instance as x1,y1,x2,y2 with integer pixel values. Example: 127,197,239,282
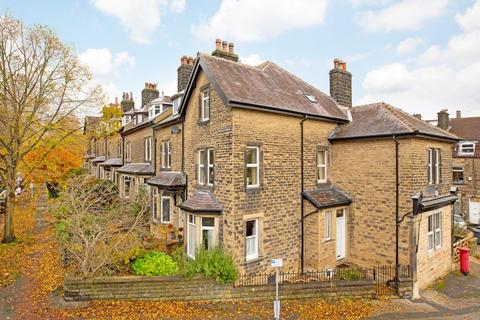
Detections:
63,276,411,301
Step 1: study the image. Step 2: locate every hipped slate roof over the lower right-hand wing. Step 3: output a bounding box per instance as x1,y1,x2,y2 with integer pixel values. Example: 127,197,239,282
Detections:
330,102,459,141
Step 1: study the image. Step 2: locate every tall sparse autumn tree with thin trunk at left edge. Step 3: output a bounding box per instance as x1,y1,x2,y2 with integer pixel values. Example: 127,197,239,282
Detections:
0,15,101,243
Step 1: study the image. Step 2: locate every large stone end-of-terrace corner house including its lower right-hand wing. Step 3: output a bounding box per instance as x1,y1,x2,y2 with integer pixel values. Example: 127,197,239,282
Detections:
142,40,458,290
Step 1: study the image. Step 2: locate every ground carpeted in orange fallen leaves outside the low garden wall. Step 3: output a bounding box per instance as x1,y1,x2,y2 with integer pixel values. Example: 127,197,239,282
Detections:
0,196,378,319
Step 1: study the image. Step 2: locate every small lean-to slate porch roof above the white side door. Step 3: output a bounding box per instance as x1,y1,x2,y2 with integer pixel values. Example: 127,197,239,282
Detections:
303,184,352,209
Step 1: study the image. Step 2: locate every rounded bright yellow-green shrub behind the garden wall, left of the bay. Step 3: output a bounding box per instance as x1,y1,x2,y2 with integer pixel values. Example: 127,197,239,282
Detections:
132,251,178,276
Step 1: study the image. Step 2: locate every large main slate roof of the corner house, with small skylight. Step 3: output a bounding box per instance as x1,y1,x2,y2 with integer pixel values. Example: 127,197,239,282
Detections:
182,53,348,122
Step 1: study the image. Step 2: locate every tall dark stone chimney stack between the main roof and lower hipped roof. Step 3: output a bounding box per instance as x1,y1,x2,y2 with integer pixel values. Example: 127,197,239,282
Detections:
329,59,352,107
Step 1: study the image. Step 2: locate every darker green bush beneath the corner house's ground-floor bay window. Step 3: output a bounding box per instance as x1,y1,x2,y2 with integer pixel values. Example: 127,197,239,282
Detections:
173,247,238,283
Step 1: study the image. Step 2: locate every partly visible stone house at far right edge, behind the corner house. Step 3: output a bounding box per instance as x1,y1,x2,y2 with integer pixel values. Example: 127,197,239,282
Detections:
438,110,480,225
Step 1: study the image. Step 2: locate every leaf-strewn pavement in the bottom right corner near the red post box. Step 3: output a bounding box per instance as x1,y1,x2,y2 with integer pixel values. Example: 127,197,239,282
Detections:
372,257,480,320
